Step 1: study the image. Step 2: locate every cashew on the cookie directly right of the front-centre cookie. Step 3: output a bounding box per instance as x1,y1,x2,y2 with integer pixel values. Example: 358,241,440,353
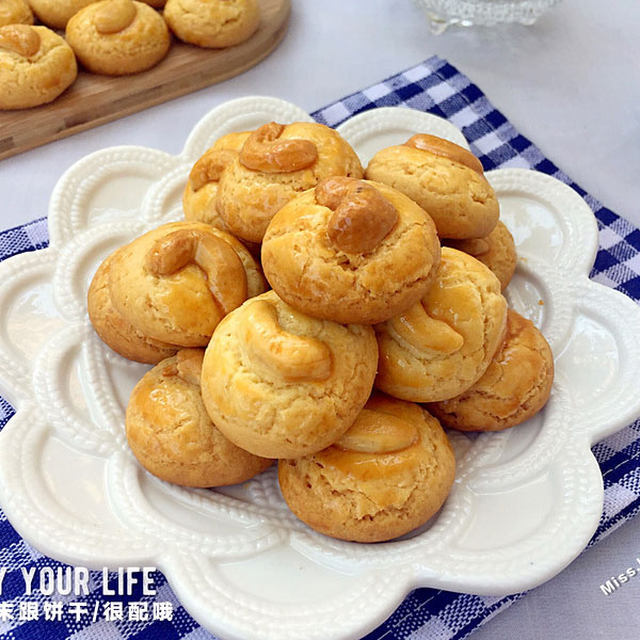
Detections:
389,302,464,355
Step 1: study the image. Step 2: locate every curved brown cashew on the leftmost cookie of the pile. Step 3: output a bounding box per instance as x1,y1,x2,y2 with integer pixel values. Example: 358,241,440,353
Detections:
146,229,247,314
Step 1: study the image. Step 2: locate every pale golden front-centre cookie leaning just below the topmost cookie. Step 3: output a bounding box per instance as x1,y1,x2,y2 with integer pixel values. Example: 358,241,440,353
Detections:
202,291,378,458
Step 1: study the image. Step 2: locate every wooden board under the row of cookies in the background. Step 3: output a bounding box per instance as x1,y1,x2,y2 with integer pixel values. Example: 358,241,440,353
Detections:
0,0,291,160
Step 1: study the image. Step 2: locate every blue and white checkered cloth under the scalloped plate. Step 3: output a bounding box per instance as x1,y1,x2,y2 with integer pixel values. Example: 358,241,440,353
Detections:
0,57,640,640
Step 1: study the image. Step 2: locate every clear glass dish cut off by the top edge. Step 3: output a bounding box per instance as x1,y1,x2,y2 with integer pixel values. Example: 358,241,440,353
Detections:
415,0,559,33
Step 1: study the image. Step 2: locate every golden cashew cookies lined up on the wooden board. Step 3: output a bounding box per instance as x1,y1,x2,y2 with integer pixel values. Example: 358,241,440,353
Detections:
0,0,260,110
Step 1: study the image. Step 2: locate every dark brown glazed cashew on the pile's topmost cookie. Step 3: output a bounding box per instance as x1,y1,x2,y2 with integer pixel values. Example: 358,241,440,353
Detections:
315,177,398,253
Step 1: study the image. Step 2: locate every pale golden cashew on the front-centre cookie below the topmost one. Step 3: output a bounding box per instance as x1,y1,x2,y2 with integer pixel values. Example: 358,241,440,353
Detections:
243,300,332,382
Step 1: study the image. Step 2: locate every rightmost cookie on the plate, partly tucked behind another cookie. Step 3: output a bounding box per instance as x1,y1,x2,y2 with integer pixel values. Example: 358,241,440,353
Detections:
428,309,554,431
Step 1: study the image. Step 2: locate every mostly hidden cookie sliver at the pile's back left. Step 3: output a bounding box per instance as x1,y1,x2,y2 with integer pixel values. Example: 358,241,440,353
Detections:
182,131,251,229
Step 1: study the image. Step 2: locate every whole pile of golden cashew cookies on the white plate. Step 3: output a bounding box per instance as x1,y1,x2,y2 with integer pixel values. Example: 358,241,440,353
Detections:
88,122,553,542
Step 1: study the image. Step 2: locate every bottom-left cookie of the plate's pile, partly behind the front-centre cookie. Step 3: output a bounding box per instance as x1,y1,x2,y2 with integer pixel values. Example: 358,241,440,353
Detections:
125,349,272,487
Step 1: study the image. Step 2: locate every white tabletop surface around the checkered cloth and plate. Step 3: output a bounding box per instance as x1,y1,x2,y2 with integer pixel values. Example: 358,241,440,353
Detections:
0,0,640,640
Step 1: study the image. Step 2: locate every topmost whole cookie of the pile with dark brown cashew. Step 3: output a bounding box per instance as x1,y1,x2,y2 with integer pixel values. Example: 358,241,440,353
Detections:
262,177,440,324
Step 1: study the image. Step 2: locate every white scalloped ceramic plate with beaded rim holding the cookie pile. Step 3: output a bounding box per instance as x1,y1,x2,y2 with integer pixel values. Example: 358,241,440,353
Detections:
0,98,640,640
